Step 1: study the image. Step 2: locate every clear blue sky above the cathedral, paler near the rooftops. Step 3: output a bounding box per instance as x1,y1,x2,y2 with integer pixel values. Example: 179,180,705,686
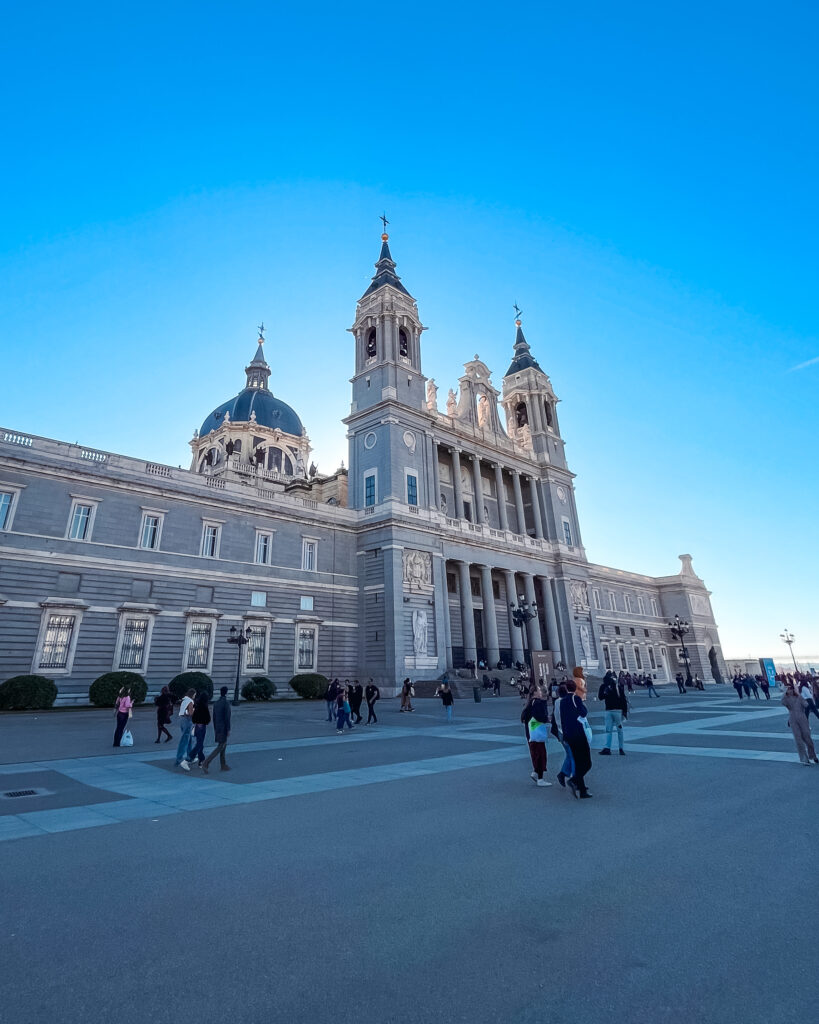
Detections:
0,2,819,656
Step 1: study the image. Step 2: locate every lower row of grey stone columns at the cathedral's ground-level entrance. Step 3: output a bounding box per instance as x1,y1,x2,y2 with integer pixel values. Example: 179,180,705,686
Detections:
445,559,562,669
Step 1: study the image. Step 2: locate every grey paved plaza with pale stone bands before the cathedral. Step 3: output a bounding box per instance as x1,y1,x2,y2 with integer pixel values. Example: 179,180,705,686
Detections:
0,687,819,1024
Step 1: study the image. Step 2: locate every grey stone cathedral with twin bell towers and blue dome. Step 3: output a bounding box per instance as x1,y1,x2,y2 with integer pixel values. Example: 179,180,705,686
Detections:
0,233,725,702
